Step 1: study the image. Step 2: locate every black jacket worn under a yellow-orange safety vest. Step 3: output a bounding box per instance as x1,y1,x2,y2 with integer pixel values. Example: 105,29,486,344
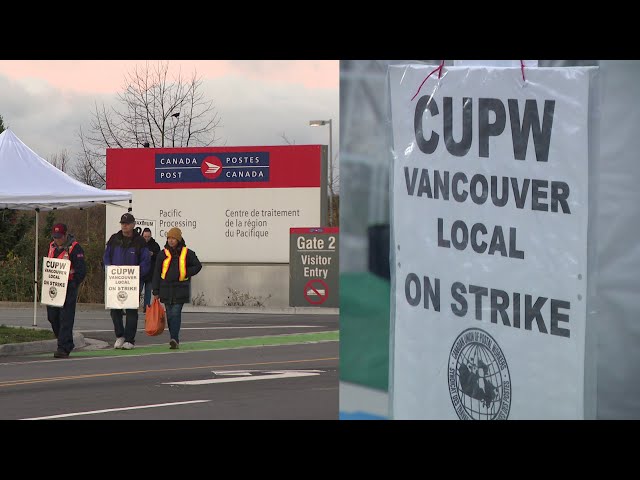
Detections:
151,239,202,305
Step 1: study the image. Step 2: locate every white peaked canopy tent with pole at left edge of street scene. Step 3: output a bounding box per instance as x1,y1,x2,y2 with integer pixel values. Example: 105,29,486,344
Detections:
0,129,133,326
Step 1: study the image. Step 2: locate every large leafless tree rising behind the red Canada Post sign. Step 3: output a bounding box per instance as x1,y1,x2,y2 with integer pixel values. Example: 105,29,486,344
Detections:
78,62,221,186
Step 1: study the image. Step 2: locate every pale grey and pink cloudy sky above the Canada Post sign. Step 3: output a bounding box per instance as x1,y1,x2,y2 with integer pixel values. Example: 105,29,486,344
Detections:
0,60,339,173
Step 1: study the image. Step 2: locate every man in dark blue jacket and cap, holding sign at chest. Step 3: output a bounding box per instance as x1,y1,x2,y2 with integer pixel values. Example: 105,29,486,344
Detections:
102,212,151,350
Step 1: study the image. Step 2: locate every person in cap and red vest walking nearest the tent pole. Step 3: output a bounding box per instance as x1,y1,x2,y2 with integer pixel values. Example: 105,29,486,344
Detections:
47,223,87,358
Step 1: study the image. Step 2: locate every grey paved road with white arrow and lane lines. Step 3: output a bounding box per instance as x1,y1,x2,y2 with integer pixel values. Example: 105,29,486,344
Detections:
0,308,339,420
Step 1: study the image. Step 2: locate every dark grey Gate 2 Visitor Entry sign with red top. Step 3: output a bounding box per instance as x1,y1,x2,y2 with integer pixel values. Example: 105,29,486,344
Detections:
289,227,340,308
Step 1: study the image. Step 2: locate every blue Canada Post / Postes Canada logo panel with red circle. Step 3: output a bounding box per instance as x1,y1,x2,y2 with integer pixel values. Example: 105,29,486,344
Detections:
155,152,270,183
